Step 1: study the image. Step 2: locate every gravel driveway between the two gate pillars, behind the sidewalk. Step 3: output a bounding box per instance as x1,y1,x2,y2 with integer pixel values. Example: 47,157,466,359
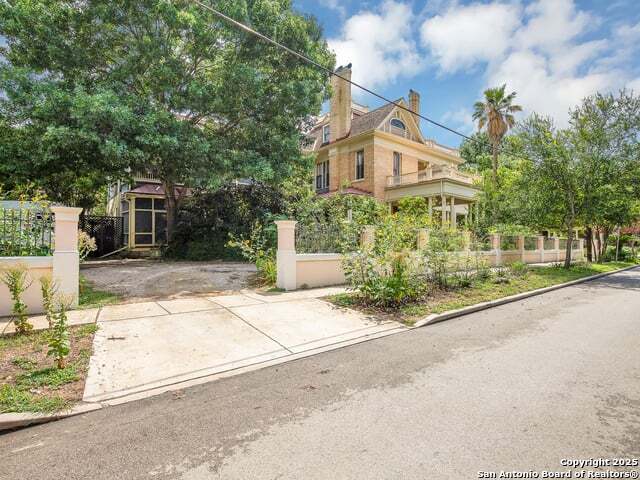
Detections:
82,260,256,301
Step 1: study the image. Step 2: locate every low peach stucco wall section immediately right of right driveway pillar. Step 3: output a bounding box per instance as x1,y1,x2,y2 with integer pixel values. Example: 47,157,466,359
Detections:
296,253,347,288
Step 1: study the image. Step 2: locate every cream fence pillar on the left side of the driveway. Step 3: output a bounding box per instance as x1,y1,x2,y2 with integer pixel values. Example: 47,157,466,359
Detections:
51,207,82,307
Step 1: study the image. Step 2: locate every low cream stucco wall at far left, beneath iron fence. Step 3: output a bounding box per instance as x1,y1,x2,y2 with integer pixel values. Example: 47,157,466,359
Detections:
0,257,53,317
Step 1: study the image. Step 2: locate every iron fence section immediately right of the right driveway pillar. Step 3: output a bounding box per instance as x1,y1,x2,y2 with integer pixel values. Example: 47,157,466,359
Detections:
296,223,361,253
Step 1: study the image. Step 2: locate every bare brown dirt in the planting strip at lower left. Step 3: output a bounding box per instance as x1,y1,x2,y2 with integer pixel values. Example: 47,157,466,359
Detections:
0,324,97,403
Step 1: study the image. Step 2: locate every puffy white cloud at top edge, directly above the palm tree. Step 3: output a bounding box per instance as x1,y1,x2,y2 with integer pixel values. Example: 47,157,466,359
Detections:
420,3,520,73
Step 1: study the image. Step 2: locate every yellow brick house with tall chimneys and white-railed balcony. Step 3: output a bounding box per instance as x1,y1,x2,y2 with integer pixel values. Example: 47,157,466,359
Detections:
309,65,478,226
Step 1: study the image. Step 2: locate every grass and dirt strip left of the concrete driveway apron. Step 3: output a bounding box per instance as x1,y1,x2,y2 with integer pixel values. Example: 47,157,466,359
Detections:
0,324,98,413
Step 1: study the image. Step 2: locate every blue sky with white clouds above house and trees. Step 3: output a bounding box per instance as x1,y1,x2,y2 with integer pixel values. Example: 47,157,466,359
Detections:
294,0,640,146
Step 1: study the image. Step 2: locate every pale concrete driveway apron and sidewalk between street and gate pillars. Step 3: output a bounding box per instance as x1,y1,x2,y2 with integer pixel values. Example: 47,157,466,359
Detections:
84,288,405,404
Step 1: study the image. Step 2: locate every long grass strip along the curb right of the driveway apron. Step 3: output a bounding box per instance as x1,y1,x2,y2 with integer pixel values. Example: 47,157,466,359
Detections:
329,262,634,325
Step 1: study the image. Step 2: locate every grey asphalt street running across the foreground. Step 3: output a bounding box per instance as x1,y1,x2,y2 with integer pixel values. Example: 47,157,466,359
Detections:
0,269,640,480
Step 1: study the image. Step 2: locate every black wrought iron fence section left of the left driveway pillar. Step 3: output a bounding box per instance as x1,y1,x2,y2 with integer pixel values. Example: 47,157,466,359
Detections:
0,208,53,257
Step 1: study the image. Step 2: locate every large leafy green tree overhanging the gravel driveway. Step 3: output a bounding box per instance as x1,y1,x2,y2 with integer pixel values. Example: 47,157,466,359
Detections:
0,0,334,235
